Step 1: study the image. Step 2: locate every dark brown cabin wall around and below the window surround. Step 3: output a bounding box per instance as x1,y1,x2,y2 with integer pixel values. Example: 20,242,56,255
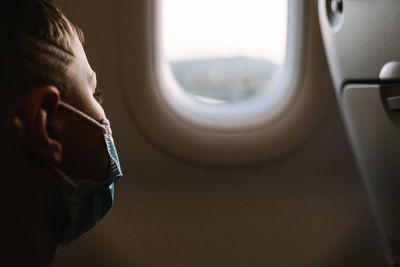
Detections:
54,0,383,267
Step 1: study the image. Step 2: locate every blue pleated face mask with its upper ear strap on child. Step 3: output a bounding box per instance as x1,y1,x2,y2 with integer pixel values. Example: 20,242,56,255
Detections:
55,102,122,245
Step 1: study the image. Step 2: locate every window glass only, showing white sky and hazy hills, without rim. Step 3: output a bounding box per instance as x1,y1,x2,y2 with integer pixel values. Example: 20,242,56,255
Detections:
160,0,288,105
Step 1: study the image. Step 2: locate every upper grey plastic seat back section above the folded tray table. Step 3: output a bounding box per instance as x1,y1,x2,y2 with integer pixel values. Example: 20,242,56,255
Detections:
319,0,400,93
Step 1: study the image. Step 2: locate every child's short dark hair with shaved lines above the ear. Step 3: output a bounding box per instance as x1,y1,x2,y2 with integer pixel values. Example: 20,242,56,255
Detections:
0,0,84,116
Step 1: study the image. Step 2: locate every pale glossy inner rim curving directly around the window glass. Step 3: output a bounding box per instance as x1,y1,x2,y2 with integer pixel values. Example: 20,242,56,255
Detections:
153,0,303,132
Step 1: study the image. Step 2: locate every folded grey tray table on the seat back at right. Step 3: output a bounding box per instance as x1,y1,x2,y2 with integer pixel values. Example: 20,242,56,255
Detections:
342,84,400,262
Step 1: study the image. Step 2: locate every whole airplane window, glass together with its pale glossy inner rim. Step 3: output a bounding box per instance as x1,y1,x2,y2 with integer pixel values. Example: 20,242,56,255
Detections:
155,0,306,132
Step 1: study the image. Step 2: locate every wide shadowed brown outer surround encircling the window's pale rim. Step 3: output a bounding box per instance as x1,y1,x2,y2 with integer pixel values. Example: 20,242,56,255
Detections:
117,0,333,169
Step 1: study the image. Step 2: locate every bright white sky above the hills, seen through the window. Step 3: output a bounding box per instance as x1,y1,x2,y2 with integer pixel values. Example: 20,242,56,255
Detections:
162,0,287,64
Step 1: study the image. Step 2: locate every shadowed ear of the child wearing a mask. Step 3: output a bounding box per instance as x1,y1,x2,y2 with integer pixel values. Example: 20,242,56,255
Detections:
9,86,62,165
